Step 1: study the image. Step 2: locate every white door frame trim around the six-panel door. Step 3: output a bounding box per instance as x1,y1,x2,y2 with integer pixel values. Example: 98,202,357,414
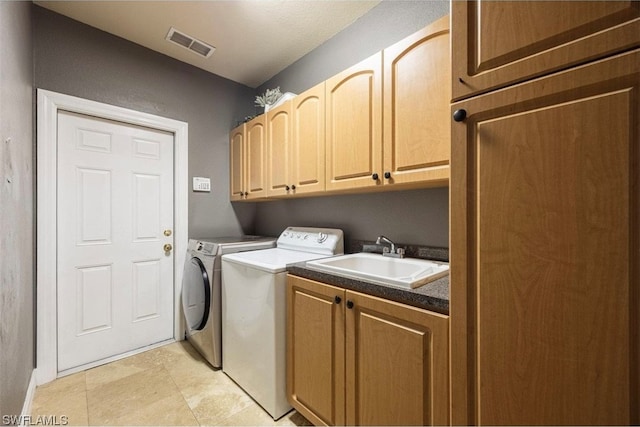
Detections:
36,89,189,385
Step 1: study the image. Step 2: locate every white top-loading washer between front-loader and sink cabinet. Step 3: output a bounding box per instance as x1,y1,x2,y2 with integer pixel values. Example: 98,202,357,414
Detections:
222,227,344,420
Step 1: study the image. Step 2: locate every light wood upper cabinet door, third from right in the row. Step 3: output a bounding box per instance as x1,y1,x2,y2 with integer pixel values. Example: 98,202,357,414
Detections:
291,82,325,194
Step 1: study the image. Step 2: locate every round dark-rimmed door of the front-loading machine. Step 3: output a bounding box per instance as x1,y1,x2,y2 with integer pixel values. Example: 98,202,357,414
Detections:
182,257,211,331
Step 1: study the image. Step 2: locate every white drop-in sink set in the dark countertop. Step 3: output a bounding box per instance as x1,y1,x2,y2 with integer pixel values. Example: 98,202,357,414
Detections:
307,253,449,289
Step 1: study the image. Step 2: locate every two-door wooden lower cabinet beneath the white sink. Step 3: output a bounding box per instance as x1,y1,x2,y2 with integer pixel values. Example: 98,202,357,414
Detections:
287,276,449,425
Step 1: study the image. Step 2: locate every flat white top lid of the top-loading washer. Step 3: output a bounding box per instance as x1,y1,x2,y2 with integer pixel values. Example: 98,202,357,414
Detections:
222,248,326,273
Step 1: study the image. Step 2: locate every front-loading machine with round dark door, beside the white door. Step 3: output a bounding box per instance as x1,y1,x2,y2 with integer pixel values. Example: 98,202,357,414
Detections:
181,236,276,368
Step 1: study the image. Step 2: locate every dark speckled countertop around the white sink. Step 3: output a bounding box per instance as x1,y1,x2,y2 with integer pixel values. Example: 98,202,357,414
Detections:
287,262,449,315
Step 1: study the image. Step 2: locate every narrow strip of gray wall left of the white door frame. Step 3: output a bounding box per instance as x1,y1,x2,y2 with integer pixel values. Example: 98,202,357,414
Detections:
0,1,35,419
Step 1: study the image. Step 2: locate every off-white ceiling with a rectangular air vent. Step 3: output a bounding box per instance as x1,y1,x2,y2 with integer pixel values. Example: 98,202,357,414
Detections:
34,0,380,88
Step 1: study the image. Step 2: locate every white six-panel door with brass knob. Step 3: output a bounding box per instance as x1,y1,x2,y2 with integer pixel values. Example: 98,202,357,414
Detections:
57,111,174,372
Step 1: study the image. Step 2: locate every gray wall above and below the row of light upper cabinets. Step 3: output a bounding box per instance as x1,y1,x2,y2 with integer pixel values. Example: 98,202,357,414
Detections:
255,1,449,247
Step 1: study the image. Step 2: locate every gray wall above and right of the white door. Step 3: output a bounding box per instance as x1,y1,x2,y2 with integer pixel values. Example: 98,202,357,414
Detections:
33,6,255,237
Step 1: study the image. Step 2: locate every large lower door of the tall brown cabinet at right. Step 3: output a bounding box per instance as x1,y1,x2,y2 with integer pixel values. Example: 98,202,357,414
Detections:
451,50,640,425
